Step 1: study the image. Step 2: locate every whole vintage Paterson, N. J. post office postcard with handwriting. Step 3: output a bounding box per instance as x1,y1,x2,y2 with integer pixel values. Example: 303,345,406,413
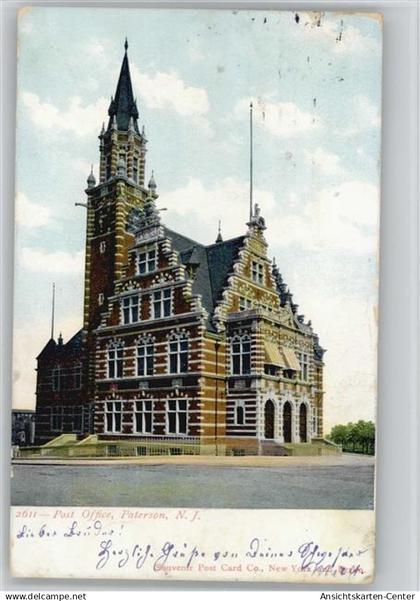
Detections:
11,7,382,585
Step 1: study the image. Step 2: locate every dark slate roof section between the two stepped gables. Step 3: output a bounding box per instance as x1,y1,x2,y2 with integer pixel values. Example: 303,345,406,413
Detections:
165,228,245,328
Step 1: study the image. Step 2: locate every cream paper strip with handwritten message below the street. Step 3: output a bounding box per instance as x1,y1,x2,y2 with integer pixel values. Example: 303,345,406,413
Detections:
11,507,375,584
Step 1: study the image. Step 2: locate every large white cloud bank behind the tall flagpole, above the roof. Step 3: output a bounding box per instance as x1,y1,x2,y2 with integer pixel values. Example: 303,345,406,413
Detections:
160,178,379,255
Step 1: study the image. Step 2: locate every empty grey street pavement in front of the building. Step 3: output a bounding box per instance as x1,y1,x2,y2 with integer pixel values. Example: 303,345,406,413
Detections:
11,455,374,509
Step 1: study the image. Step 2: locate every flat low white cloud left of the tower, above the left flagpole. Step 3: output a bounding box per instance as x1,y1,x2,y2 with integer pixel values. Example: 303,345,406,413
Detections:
20,247,84,275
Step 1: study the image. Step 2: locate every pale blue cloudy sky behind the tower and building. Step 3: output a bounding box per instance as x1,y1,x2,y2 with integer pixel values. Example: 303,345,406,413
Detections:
13,7,382,431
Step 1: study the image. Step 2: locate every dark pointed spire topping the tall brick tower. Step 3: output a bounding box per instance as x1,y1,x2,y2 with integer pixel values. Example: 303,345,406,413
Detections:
108,38,140,133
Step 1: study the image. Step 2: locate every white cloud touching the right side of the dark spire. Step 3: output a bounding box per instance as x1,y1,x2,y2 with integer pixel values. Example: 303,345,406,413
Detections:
131,65,210,117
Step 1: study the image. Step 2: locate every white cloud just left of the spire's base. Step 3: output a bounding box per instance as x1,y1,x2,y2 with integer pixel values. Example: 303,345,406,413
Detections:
21,92,109,136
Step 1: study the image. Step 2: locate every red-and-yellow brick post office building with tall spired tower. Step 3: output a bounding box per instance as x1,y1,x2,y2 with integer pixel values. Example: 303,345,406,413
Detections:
36,47,324,452
